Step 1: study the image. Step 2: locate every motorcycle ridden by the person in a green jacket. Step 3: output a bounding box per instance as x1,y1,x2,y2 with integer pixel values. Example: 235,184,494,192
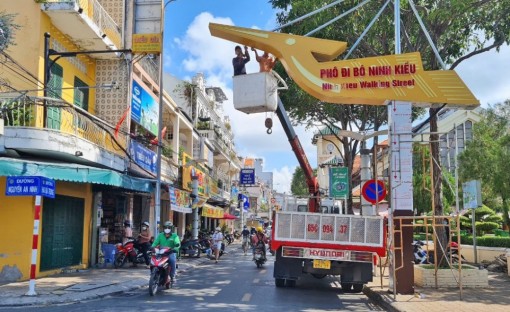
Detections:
149,247,175,296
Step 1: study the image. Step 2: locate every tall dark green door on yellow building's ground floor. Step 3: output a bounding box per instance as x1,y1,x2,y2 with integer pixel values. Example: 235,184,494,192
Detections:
40,195,84,271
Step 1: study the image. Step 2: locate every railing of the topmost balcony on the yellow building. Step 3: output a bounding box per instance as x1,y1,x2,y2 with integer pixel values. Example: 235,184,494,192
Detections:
41,0,122,48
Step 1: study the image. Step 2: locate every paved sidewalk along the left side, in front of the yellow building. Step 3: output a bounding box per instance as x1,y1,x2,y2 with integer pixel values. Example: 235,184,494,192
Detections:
0,249,223,308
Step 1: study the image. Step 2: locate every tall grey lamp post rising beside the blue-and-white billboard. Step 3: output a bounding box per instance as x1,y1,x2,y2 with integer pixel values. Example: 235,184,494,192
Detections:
154,0,175,233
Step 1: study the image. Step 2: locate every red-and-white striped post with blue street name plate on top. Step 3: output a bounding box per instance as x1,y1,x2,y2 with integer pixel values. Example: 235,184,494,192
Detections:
5,176,55,296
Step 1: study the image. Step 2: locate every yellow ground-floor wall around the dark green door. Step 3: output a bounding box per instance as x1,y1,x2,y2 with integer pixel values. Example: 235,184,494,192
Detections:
0,177,92,280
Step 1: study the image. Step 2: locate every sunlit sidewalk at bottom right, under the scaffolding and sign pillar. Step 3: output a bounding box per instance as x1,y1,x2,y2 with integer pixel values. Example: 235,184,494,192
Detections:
363,269,510,312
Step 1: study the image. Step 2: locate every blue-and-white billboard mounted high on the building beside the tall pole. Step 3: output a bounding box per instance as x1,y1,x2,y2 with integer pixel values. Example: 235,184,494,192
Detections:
131,80,159,136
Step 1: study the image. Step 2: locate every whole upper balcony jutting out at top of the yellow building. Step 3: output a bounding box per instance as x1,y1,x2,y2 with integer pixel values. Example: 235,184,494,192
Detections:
41,0,122,59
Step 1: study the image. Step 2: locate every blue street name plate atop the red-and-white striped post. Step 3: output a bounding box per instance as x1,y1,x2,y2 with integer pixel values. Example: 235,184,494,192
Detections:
5,176,55,198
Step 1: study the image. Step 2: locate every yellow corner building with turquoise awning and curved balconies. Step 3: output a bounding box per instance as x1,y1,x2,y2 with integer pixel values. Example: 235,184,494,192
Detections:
0,0,153,282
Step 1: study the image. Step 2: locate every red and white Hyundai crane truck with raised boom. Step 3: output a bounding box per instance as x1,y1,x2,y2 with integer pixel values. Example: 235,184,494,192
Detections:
271,97,386,292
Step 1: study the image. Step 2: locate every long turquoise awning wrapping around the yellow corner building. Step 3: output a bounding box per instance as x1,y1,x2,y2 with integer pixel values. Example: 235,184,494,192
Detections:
0,158,155,193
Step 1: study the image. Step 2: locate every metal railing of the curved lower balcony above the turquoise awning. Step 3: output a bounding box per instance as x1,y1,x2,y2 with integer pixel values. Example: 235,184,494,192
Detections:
0,96,126,157
